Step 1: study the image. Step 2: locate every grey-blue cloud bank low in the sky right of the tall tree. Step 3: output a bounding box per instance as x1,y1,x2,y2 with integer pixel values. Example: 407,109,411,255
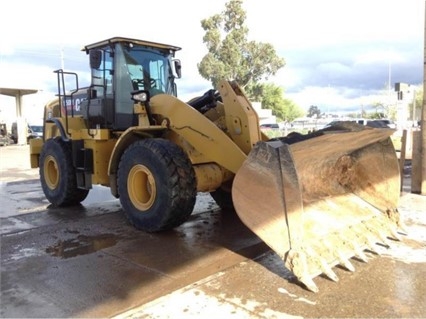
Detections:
275,33,423,111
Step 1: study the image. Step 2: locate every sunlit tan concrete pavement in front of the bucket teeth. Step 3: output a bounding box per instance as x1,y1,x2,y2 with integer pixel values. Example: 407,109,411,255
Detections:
115,194,426,319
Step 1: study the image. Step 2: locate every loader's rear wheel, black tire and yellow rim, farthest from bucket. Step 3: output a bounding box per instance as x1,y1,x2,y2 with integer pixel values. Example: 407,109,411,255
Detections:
40,138,89,207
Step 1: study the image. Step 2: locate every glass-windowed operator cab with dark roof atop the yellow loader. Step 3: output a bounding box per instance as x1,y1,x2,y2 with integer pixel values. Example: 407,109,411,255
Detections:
57,37,181,130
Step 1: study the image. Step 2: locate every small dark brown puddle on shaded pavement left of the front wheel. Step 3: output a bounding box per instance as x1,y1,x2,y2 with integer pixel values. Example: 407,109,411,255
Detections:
46,234,119,259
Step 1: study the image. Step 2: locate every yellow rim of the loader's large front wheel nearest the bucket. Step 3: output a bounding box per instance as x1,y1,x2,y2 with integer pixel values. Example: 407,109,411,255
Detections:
127,164,157,211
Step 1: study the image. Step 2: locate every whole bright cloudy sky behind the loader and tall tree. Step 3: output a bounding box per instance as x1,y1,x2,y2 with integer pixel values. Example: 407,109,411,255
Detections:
0,0,425,120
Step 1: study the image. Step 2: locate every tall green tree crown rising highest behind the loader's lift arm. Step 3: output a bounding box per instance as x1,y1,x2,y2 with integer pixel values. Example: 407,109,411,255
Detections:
197,0,285,88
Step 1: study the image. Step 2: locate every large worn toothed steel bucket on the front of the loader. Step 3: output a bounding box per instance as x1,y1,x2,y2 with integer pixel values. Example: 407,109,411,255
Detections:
232,123,403,292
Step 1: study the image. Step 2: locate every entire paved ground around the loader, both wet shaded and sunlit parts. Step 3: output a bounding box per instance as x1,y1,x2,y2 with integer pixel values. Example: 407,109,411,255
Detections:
0,146,426,318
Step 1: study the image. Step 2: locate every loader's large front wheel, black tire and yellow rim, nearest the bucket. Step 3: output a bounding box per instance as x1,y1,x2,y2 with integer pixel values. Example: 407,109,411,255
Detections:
117,139,197,232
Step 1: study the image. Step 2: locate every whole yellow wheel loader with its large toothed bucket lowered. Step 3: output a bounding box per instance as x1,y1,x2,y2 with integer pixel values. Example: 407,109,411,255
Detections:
30,37,403,292
